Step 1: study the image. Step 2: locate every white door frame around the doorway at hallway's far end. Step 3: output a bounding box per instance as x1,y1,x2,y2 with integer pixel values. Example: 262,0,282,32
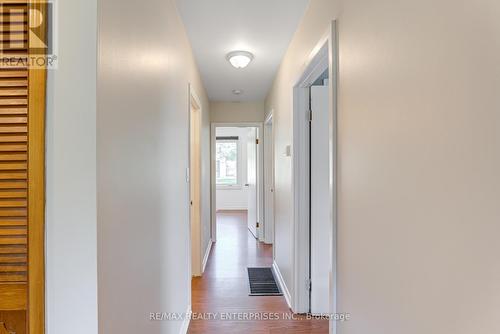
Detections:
210,122,264,242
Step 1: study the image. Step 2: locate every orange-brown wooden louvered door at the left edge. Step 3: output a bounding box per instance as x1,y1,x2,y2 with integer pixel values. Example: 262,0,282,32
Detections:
0,0,46,334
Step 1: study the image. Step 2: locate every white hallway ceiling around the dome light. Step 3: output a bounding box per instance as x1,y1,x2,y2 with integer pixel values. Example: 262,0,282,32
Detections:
177,0,309,101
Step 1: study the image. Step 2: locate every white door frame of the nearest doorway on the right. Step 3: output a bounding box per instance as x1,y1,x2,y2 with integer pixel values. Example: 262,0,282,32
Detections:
292,21,338,333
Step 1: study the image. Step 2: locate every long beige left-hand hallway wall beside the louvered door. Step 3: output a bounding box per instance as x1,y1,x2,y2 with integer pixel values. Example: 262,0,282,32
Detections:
97,0,210,333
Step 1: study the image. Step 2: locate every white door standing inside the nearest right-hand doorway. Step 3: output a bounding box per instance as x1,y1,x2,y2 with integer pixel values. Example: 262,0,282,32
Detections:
311,86,331,314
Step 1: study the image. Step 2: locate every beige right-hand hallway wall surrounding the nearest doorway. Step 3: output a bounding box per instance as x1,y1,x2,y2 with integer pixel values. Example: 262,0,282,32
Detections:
266,0,500,334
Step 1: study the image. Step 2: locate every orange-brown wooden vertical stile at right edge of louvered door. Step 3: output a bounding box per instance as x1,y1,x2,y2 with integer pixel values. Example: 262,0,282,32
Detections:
27,0,50,334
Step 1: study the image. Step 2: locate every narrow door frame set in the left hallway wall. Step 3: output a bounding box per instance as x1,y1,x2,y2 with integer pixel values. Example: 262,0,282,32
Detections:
186,84,203,279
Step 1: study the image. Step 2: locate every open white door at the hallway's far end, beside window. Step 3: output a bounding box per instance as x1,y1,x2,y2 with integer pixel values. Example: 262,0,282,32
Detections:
245,128,258,238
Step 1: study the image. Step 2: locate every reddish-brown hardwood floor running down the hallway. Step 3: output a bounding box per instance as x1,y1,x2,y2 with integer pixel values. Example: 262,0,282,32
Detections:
188,212,328,334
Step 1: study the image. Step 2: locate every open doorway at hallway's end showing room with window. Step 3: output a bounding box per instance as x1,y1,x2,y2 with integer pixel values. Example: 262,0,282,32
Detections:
213,124,264,240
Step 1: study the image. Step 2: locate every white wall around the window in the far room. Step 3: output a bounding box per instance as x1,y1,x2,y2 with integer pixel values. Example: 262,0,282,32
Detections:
216,128,249,210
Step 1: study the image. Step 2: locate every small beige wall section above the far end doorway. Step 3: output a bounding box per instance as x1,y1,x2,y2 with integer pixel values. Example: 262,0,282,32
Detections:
210,102,265,123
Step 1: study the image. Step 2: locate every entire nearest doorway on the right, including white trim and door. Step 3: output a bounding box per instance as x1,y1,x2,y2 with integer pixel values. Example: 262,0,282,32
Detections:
292,23,337,320
